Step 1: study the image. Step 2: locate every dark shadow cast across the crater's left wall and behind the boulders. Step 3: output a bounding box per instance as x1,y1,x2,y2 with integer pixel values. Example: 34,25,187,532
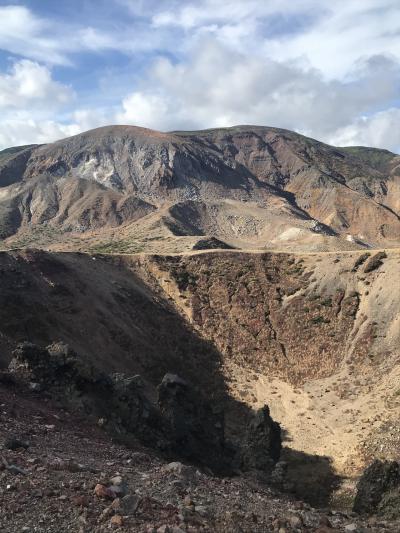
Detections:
0,250,338,505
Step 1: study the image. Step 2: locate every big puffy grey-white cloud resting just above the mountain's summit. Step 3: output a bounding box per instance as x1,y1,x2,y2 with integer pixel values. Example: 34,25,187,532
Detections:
118,40,400,143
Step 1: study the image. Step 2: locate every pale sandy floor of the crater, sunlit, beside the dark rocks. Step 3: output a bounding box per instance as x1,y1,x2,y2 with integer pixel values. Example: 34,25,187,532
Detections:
227,358,400,477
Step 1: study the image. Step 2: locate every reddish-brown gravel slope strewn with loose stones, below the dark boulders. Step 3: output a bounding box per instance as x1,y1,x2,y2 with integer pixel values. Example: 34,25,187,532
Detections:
0,385,400,533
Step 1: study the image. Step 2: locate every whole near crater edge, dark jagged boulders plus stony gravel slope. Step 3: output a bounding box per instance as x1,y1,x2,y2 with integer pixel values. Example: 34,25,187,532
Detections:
0,344,400,533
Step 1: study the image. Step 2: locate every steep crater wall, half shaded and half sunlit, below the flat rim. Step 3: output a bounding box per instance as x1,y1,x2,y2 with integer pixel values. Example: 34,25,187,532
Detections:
0,250,400,477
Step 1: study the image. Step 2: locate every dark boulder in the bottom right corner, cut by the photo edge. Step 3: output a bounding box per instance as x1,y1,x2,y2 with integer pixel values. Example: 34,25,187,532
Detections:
353,460,400,518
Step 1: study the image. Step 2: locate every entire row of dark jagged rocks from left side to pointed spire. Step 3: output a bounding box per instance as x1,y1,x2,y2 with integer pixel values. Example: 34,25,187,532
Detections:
9,343,281,471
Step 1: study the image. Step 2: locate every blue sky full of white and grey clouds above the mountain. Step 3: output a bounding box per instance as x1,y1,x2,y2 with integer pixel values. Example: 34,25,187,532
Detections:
0,0,400,153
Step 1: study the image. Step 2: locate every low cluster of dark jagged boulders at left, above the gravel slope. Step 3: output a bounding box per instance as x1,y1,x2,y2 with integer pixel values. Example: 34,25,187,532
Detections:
9,343,161,444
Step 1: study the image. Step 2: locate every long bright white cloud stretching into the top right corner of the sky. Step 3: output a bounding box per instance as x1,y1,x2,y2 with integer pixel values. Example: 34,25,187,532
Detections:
152,0,400,79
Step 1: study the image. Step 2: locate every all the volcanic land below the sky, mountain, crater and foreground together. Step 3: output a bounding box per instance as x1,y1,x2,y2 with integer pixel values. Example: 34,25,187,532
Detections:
0,126,400,532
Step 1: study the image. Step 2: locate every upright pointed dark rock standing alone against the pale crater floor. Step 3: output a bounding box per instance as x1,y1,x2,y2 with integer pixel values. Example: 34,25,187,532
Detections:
242,405,282,472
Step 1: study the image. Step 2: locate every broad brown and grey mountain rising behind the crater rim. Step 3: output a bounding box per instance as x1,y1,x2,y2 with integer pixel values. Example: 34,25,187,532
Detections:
0,126,400,252
